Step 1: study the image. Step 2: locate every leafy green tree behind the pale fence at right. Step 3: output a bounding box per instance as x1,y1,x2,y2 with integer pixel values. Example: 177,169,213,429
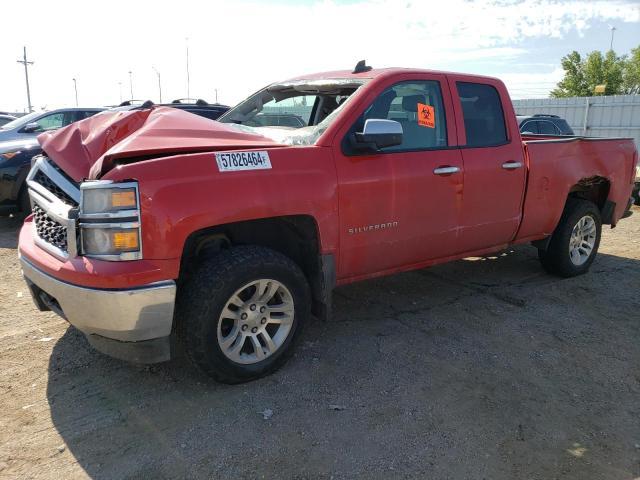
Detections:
551,47,640,97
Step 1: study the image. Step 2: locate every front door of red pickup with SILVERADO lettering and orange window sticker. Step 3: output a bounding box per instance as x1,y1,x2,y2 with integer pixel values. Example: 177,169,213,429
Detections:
334,74,463,278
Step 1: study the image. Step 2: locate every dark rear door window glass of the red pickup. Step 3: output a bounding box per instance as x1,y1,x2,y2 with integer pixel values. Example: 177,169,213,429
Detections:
456,82,507,147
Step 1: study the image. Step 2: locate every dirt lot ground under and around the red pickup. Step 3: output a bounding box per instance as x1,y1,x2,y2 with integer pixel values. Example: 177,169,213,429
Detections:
0,208,640,480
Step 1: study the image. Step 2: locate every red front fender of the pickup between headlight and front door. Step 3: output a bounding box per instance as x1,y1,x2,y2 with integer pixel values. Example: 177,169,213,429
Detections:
103,146,338,259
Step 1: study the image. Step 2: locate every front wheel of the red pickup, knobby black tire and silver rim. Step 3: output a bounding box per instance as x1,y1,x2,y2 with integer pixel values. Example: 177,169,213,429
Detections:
176,246,310,384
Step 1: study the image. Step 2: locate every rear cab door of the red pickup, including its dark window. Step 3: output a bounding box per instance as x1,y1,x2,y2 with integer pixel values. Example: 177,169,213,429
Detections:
447,74,526,253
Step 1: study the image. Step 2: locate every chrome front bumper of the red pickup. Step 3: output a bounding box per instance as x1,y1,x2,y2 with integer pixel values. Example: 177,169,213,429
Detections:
20,256,176,363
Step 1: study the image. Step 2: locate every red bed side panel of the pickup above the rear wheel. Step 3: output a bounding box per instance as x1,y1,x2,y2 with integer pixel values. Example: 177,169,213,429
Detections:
515,138,635,241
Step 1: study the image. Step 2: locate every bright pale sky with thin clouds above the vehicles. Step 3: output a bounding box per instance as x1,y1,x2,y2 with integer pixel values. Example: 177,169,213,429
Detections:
0,0,640,110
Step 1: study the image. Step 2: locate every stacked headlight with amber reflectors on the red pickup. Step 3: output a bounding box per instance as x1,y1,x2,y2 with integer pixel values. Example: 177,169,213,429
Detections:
79,180,142,261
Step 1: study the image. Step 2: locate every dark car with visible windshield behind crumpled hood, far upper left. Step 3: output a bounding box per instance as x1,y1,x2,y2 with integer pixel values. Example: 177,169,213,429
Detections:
0,108,106,142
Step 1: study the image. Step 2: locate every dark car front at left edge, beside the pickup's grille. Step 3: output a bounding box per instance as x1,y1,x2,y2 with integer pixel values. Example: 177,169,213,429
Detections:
0,137,42,215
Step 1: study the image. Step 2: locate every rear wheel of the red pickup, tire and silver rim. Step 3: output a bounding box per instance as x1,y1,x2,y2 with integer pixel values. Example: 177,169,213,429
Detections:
538,198,602,277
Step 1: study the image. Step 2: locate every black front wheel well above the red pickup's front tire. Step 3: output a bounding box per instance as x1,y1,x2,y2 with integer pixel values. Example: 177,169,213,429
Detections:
180,215,335,317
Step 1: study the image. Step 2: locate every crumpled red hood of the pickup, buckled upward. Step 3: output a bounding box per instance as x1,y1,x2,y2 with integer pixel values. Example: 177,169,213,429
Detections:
38,107,283,182
